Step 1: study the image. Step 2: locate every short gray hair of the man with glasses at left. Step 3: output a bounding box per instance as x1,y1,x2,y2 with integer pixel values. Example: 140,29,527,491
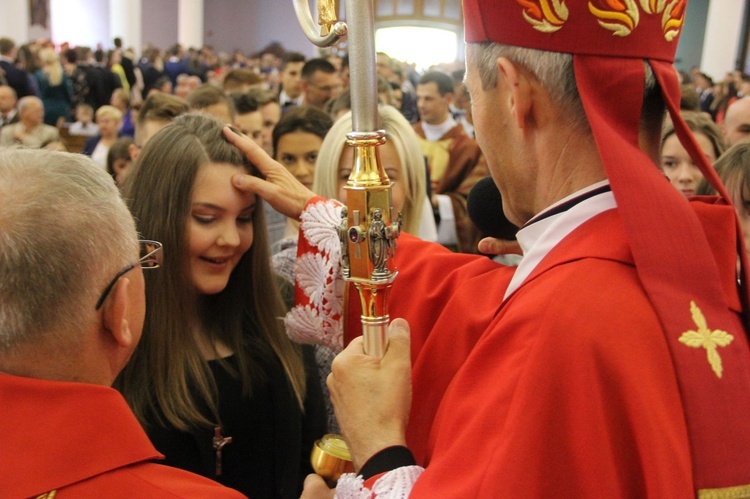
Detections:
0,148,137,355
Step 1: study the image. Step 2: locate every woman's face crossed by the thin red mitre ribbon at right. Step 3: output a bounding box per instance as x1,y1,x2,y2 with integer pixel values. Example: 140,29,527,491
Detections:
661,112,726,196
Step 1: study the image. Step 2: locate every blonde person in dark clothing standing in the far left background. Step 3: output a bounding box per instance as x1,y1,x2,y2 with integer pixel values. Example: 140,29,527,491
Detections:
34,48,73,126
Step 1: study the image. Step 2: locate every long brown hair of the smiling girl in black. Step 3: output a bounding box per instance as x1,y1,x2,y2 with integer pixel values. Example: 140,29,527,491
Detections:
115,115,305,430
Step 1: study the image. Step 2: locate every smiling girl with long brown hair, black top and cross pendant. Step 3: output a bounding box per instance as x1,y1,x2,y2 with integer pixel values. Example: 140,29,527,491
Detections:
115,114,325,499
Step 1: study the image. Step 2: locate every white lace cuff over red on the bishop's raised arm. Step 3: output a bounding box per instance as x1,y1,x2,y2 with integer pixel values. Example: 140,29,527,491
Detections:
284,200,344,351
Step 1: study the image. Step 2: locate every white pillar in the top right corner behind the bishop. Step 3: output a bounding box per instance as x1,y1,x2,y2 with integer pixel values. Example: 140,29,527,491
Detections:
701,0,745,80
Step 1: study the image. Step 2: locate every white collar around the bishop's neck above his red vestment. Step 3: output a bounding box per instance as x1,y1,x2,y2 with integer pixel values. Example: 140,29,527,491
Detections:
503,180,617,300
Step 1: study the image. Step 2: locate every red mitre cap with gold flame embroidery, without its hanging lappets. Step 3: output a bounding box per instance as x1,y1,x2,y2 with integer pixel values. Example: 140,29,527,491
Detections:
463,0,687,62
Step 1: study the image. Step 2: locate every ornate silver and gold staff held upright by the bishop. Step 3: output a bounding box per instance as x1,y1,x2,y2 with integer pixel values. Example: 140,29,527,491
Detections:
295,0,401,357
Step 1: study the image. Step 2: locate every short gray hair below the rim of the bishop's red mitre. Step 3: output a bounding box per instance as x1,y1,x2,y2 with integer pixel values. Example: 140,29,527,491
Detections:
466,42,663,131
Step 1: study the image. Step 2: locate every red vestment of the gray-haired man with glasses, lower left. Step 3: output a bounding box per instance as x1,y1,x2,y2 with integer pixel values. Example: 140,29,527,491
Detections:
0,373,244,499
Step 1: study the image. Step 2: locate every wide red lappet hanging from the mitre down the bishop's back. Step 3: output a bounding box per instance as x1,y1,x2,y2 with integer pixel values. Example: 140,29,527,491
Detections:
574,55,750,488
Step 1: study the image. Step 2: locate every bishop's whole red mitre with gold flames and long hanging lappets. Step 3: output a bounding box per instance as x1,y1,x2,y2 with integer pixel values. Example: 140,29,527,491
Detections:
463,0,750,490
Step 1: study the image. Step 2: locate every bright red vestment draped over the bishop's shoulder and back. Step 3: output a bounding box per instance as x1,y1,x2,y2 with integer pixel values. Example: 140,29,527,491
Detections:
402,206,750,498
